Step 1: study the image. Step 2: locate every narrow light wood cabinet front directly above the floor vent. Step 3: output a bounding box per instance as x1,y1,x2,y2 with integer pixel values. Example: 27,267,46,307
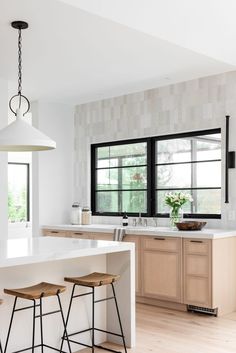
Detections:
183,239,212,308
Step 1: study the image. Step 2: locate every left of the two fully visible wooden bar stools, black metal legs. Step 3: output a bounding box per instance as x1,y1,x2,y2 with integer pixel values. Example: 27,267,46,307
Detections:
4,282,71,353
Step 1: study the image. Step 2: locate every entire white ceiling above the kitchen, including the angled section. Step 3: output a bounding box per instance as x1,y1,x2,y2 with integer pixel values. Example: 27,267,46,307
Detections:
0,0,236,104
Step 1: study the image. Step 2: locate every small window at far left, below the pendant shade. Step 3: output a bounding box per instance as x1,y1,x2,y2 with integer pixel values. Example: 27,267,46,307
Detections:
8,162,30,223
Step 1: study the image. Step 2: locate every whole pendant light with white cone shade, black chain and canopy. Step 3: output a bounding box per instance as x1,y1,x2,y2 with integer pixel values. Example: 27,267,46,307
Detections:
0,21,56,152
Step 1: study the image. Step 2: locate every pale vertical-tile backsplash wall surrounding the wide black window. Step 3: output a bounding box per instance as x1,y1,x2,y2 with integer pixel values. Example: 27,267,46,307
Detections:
74,71,236,228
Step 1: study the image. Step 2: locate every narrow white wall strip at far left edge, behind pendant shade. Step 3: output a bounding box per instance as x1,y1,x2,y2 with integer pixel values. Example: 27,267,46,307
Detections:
0,79,8,239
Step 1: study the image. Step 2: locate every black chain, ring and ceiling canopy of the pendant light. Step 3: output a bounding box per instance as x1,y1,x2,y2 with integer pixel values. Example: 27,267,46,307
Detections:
9,21,30,115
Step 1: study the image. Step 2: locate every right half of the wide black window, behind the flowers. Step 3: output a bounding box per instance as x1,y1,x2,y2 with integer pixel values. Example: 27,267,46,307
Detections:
155,132,221,216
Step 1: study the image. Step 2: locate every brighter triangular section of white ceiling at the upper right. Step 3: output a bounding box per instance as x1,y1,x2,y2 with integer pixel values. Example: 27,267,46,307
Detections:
61,0,236,65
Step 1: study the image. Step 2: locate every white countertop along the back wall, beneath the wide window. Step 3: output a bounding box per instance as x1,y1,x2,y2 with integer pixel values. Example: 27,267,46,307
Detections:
42,224,236,239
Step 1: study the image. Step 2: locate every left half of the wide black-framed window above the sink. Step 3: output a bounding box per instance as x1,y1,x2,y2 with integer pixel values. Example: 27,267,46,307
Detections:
92,141,147,214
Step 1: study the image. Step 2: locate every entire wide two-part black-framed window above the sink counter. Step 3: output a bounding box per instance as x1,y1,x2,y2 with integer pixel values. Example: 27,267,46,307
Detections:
91,129,221,218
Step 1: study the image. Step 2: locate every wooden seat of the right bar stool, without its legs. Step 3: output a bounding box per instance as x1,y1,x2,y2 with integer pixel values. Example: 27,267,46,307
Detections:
64,272,120,287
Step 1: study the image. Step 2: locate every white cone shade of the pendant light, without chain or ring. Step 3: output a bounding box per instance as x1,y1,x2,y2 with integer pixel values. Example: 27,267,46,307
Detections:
0,109,56,152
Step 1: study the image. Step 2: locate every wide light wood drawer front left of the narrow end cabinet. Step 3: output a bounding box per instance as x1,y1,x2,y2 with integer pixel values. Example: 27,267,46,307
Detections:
143,236,181,252
